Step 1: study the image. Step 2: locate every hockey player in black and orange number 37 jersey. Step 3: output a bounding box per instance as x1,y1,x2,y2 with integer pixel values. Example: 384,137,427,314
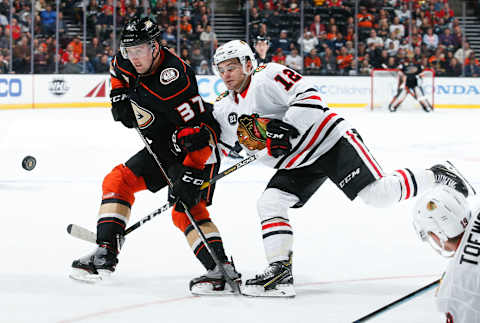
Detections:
70,18,240,294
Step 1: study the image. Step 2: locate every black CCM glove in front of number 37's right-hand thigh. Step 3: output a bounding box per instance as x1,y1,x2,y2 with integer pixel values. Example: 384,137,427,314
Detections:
172,166,205,208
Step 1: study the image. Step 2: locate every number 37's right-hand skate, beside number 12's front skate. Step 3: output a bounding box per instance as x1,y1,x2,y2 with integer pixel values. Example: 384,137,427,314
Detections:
190,261,242,295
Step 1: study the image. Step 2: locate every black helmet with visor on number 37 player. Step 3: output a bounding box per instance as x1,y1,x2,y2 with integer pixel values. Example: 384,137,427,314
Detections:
120,17,162,59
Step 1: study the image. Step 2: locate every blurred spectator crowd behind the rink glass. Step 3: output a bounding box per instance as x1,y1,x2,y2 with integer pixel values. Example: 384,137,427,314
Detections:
0,0,480,76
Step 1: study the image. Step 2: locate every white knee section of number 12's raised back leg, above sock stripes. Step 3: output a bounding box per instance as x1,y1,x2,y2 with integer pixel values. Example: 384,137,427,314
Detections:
358,175,402,207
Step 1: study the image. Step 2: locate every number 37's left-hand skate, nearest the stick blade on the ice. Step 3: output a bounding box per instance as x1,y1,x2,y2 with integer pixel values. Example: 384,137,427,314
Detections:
69,242,118,283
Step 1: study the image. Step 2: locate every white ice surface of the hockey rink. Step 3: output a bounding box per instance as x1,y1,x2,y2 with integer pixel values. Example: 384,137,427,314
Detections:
0,109,480,323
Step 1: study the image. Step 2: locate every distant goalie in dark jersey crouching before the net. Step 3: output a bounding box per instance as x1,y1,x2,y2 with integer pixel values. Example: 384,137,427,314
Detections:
388,62,433,112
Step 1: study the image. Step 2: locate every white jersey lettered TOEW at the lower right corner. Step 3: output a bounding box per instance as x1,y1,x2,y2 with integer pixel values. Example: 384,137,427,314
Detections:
437,201,480,323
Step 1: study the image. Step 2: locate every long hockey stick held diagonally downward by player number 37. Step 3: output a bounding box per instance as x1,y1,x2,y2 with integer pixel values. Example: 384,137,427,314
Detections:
135,127,240,295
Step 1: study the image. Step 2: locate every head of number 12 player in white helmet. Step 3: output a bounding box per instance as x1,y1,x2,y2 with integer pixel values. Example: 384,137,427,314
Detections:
213,40,257,92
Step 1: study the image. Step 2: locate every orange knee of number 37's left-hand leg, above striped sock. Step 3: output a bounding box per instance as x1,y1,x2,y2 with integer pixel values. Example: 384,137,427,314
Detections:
102,165,147,206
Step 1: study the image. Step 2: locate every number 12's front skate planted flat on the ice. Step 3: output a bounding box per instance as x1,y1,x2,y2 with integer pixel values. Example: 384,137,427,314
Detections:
242,256,296,297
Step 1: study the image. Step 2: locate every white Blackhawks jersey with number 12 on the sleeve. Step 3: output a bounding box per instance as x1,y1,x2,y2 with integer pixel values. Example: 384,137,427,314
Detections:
213,63,351,169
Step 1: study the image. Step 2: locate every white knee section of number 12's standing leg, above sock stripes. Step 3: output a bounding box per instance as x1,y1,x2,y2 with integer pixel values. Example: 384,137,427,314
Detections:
257,188,299,221
